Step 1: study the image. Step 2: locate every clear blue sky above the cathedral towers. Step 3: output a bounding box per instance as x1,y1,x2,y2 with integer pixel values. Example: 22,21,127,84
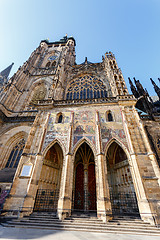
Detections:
0,0,160,95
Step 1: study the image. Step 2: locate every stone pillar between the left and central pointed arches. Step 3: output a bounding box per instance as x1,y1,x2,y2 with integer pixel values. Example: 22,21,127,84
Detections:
57,112,74,219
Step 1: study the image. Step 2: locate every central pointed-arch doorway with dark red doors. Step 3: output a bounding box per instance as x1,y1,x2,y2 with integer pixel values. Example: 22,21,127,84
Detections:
73,143,97,212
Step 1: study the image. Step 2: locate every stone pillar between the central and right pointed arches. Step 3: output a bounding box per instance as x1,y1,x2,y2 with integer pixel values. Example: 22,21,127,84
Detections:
96,111,112,222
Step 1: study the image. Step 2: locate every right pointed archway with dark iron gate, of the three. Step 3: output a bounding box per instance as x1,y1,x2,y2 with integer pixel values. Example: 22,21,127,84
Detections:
106,142,139,216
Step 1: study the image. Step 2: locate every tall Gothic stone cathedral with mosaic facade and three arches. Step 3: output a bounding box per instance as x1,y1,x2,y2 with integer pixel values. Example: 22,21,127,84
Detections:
0,36,160,224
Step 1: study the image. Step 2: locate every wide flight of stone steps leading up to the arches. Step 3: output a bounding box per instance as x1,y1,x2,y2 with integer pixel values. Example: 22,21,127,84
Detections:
2,213,160,236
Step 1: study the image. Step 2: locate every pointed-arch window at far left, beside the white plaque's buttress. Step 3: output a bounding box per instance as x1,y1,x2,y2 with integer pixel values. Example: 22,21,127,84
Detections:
5,139,25,168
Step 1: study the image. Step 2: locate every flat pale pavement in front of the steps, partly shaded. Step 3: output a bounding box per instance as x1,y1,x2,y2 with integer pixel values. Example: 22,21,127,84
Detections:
0,226,160,240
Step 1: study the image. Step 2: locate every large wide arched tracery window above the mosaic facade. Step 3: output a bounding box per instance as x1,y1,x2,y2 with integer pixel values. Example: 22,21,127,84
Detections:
66,75,107,100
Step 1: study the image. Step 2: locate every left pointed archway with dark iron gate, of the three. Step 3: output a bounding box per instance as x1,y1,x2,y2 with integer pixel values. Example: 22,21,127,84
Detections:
34,143,63,211
